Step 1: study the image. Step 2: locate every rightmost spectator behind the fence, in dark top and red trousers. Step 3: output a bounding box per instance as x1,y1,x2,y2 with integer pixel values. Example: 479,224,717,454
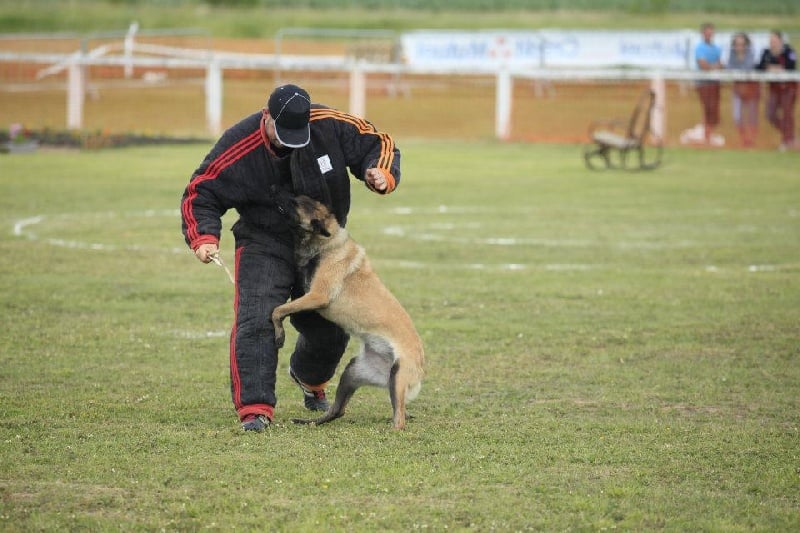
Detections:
756,30,798,151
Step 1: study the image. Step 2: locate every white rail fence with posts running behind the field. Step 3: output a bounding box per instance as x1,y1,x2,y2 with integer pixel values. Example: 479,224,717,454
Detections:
0,27,800,139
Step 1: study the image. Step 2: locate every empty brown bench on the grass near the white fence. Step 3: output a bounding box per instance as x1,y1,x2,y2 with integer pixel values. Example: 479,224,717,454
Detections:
583,90,663,170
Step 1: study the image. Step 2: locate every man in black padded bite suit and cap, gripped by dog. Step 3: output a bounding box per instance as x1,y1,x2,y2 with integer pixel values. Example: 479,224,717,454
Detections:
181,85,400,431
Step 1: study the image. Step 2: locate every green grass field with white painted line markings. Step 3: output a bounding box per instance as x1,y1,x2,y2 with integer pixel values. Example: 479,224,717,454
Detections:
0,139,800,531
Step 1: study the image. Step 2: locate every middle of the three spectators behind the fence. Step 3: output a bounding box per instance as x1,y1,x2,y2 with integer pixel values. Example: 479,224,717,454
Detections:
727,33,761,147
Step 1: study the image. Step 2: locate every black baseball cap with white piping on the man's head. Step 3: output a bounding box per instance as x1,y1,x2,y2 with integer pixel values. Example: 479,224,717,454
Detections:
267,84,311,148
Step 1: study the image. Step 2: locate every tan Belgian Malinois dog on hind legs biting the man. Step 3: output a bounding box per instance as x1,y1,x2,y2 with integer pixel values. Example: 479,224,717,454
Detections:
272,195,425,429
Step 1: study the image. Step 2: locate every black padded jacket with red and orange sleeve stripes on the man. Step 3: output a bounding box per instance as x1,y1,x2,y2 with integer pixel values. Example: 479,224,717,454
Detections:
181,104,400,250
